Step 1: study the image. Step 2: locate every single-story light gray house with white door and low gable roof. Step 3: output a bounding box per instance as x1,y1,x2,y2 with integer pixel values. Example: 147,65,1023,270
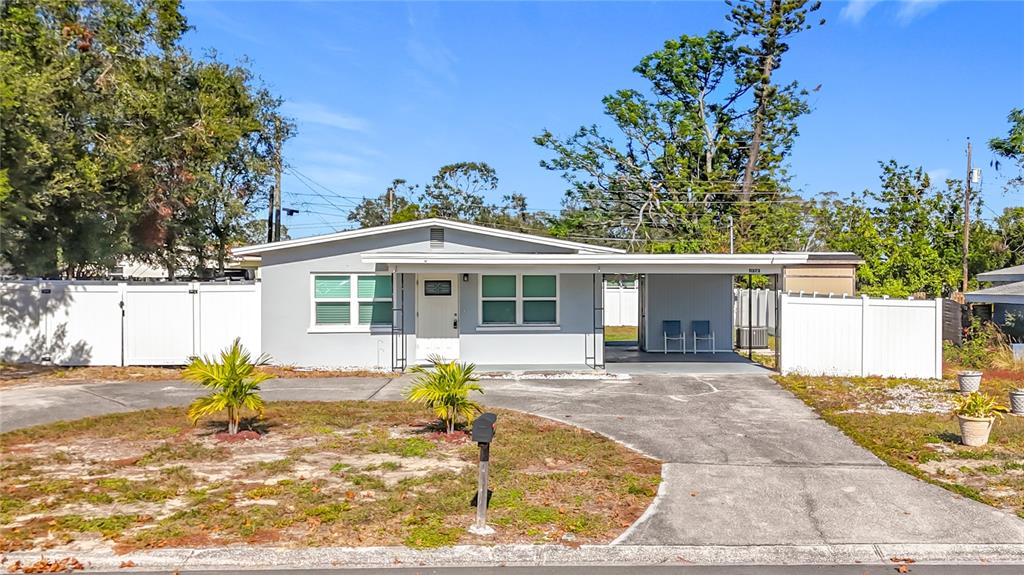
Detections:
233,219,859,369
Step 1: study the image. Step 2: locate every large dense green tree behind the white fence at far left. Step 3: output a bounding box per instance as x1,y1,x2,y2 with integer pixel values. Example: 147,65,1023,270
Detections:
0,0,288,277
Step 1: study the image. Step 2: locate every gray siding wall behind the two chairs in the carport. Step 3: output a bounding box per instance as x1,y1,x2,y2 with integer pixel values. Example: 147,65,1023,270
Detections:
646,274,732,352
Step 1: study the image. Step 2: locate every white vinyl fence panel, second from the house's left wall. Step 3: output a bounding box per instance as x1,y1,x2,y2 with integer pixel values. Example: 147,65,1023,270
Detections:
125,283,196,365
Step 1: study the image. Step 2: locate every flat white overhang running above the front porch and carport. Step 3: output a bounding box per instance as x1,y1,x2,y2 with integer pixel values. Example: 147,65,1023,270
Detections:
361,252,808,274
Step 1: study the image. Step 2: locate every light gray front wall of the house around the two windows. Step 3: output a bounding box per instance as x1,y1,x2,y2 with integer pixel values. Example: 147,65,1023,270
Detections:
261,224,603,368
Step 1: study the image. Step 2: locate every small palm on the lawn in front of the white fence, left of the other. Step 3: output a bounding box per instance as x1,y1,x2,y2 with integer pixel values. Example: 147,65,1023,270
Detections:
183,338,272,435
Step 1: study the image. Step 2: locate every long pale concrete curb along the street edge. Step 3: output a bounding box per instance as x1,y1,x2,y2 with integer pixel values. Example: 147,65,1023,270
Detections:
6,543,1024,571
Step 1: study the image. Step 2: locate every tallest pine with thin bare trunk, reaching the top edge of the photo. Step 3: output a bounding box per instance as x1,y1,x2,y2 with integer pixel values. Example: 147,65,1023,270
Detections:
726,0,824,202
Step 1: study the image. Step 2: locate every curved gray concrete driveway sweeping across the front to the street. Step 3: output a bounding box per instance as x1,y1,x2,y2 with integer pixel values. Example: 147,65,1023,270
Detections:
0,373,1024,545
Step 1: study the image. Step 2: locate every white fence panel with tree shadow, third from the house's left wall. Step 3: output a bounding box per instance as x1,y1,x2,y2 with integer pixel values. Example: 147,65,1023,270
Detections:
43,281,122,365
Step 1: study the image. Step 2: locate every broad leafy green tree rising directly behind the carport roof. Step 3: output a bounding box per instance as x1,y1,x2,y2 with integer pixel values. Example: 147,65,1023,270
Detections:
535,26,808,252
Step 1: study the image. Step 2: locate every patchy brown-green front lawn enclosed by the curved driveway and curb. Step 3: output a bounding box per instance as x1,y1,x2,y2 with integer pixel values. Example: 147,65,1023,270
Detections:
0,402,660,551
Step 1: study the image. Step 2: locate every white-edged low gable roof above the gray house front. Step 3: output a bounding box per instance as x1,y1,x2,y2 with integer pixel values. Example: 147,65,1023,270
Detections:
231,218,626,256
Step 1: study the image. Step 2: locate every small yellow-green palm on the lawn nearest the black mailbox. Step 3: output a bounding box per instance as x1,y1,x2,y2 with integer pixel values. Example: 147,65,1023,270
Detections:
404,357,483,433
